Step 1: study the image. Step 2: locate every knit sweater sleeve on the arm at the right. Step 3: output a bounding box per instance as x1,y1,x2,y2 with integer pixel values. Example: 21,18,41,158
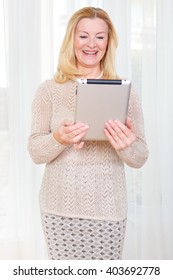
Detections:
117,88,149,168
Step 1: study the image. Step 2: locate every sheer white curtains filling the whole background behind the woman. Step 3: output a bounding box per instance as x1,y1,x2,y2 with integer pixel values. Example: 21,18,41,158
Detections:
0,0,173,259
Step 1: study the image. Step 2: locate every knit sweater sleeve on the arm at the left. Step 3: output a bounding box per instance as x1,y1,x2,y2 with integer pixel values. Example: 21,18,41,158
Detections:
28,82,66,164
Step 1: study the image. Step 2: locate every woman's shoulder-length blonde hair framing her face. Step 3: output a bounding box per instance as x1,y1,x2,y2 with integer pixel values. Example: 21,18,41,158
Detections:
54,7,118,83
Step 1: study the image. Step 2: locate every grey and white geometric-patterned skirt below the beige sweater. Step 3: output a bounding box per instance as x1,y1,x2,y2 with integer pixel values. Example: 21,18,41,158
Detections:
41,213,126,260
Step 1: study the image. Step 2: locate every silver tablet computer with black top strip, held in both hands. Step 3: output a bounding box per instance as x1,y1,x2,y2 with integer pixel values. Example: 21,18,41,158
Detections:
75,79,131,141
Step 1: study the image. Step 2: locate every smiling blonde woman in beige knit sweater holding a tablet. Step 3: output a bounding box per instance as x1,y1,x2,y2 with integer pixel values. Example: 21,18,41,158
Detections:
28,7,148,260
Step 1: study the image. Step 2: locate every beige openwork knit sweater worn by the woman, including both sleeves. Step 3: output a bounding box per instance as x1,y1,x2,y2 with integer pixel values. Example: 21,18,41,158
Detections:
28,80,148,221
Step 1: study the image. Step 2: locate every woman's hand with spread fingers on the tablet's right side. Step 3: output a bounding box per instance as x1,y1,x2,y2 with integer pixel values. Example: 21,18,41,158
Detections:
104,117,136,150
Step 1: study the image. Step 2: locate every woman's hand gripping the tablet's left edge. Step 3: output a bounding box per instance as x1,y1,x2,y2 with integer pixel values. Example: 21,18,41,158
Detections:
53,120,89,149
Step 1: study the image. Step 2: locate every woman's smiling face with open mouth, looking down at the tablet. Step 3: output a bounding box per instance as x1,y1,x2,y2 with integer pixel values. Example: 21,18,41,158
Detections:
74,18,108,73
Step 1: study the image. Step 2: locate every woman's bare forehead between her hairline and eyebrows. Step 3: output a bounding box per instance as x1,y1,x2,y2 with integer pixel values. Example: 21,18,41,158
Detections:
76,17,108,33
